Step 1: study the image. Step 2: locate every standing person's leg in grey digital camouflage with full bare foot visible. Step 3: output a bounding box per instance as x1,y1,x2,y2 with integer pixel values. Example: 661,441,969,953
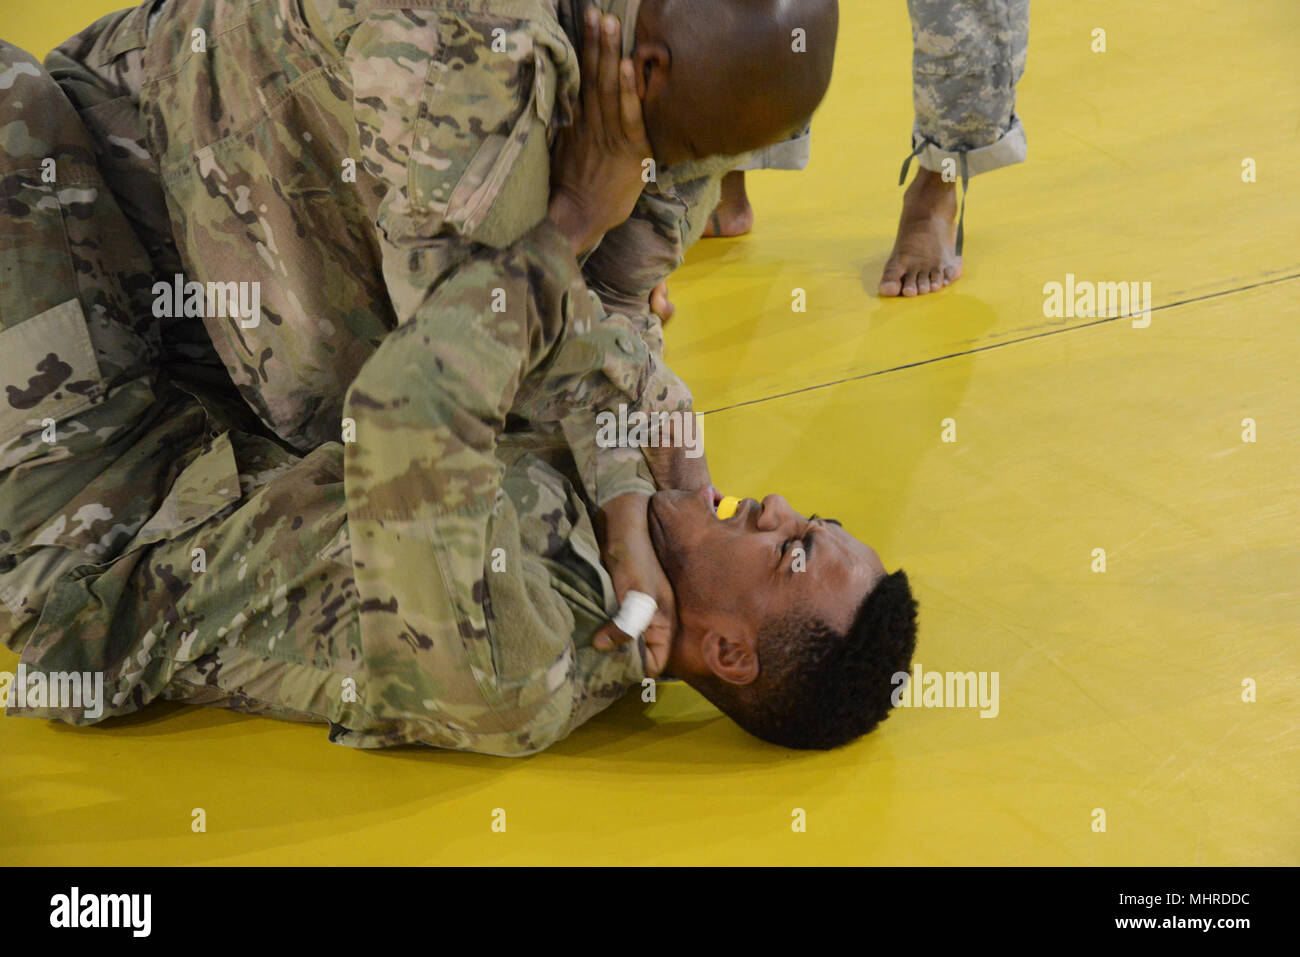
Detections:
880,0,1030,296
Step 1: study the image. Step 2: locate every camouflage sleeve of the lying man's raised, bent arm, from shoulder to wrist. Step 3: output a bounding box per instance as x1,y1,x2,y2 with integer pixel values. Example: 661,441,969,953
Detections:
346,222,644,754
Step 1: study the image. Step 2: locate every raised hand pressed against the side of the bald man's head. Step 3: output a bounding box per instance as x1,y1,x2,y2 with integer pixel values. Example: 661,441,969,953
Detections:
550,8,651,254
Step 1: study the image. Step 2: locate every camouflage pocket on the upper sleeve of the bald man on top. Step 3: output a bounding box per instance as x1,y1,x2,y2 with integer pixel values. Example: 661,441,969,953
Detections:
407,14,556,248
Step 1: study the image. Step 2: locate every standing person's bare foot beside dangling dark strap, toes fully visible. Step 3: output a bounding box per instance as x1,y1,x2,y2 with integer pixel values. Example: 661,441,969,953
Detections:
878,168,962,296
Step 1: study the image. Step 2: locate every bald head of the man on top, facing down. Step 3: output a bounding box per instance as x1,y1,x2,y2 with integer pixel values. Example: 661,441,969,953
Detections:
646,0,839,159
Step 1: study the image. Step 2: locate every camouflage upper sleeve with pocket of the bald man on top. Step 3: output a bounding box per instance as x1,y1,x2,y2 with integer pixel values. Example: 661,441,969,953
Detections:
346,3,575,248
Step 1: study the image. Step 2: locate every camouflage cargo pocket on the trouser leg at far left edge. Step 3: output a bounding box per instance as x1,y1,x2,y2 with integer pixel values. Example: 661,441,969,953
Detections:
0,297,104,449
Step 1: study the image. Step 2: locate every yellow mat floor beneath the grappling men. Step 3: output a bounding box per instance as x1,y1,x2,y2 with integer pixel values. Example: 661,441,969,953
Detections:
0,0,1300,865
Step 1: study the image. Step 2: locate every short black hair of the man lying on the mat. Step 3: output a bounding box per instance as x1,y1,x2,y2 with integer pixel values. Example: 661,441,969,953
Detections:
702,568,917,750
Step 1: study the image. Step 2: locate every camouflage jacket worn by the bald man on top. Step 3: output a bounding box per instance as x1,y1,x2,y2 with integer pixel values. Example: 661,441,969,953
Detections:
46,0,733,460
